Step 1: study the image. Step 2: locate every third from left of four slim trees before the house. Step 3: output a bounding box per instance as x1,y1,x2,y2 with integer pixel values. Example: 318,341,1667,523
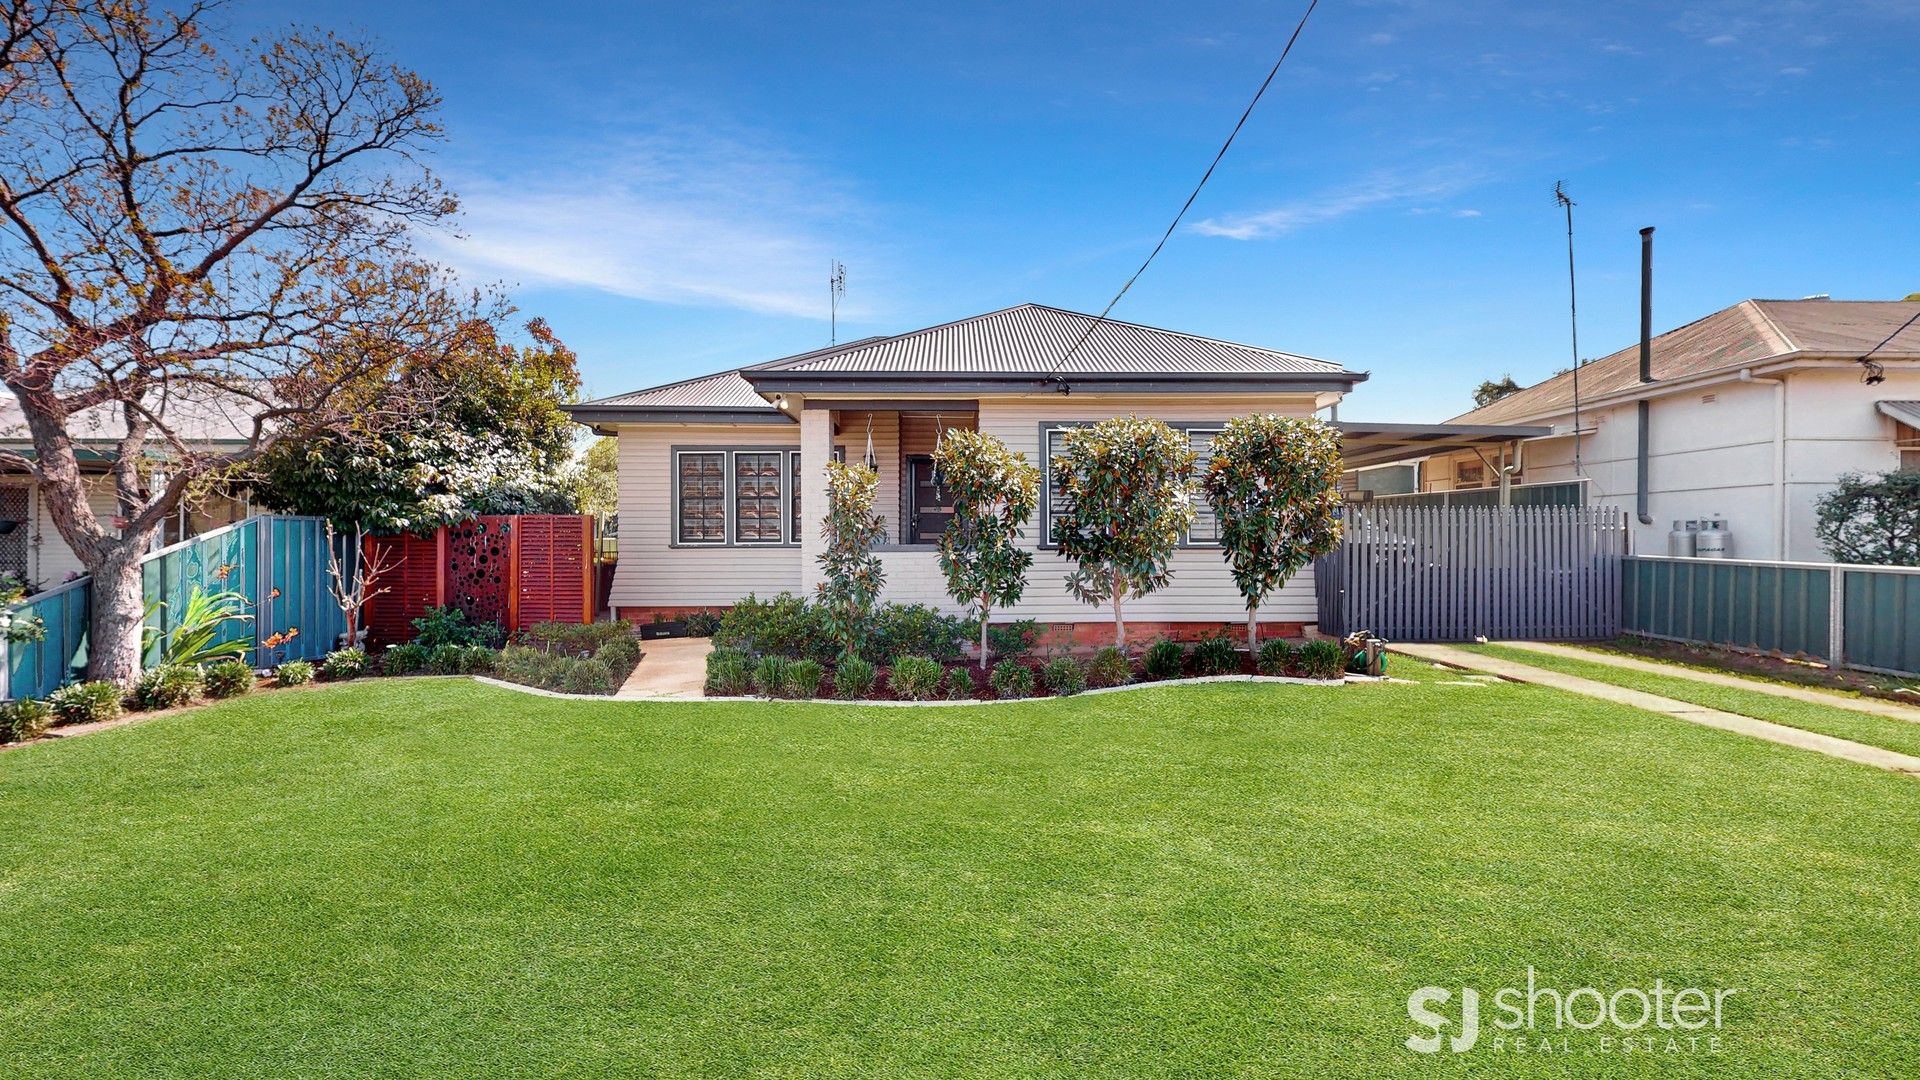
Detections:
1056,417,1194,650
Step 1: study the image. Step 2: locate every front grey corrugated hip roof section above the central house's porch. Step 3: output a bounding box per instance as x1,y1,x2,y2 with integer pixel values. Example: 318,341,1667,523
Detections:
747,304,1344,375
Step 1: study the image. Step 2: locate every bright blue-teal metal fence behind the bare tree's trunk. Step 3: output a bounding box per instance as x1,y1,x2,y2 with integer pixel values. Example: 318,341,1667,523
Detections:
0,515,355,698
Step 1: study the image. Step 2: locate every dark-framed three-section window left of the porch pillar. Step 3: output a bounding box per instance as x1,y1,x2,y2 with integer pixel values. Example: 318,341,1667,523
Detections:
672,446,801,546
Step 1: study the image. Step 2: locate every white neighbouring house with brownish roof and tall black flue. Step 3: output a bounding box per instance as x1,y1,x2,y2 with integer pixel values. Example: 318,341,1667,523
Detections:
1361,300,1920,561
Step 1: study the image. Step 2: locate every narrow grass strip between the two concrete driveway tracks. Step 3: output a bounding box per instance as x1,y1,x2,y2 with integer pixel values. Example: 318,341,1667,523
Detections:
1463,646,1920,755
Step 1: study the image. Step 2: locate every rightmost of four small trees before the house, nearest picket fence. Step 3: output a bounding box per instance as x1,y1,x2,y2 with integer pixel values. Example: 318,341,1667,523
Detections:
1204,413,1340,650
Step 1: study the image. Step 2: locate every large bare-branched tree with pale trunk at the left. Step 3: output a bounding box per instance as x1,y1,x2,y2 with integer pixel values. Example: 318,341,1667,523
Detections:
0,0,470,684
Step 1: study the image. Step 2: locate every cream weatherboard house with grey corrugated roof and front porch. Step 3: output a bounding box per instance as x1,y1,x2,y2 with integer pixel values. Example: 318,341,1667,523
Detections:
568,304,1544,640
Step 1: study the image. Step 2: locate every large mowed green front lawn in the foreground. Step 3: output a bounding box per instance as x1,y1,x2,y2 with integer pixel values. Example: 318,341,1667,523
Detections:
0,657,1920,1078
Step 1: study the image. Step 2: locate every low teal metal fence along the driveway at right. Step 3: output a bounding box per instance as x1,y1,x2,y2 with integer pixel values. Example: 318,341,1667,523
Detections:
1620,555,1920,675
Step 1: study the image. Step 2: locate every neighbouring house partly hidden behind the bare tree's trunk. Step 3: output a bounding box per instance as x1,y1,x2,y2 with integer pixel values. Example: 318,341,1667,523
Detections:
0,392,252,592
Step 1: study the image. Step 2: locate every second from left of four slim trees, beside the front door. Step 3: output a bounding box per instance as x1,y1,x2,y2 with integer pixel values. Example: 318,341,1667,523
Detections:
933,430,1041,671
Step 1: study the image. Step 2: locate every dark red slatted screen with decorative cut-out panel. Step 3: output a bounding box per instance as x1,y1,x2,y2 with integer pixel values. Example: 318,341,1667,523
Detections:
363,513,593,646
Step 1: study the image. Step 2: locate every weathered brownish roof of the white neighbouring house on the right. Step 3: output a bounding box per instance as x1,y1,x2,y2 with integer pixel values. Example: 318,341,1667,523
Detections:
1450,300,1920,425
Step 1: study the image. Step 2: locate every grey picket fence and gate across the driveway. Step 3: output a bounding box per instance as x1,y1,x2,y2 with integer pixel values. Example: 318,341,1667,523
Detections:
1313,503,1628,642
